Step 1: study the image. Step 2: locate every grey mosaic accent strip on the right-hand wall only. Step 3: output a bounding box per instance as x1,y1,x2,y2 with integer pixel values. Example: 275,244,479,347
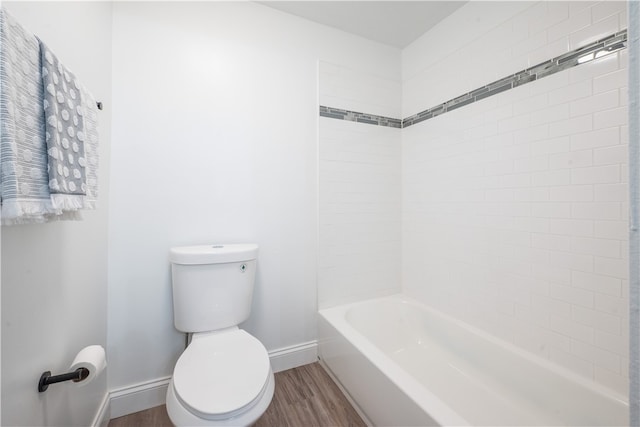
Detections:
402,30,627,128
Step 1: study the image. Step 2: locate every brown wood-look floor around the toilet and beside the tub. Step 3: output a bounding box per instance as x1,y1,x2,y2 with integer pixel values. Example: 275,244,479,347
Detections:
109,363,366,427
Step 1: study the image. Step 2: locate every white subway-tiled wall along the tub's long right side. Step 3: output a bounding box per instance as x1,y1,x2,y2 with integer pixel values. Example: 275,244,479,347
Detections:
402,2,628,396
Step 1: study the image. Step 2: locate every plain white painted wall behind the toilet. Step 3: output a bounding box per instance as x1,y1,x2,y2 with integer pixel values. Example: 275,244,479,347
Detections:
108,2,400,389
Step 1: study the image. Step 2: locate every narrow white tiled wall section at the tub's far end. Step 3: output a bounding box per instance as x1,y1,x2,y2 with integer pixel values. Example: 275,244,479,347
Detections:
318,62,402,308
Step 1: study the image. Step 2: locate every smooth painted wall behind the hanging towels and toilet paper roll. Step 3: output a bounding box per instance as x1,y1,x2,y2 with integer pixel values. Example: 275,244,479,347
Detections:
2,1,111,426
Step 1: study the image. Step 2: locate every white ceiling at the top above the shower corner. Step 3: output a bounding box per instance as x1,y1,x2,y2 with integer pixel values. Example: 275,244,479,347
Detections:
258,0,466,48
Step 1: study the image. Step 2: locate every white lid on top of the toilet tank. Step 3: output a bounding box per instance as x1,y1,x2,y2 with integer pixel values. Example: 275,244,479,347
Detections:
169,243,258,265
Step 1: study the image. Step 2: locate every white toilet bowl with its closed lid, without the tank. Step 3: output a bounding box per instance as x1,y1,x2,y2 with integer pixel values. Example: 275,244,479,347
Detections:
167,327,275,426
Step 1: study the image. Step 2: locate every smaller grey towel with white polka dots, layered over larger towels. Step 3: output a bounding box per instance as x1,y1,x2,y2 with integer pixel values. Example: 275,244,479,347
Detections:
40,40,87,211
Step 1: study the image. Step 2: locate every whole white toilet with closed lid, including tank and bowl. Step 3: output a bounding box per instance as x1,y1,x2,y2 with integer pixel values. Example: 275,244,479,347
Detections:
167,244,275,426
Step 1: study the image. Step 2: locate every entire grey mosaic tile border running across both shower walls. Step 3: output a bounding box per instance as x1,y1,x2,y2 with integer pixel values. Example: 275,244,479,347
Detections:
320,29,627,128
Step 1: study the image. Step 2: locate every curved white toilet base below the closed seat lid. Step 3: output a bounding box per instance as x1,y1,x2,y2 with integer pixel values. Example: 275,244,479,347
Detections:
167,371,275,427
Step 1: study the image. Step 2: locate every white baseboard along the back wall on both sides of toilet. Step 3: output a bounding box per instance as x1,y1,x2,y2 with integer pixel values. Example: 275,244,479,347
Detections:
110,340,318,427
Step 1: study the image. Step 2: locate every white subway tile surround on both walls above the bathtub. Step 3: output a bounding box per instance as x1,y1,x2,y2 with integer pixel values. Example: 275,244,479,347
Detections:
319,2,629,412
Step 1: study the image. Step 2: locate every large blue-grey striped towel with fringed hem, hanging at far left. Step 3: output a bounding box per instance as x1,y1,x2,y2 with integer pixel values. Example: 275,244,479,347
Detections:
0,9,57,224
